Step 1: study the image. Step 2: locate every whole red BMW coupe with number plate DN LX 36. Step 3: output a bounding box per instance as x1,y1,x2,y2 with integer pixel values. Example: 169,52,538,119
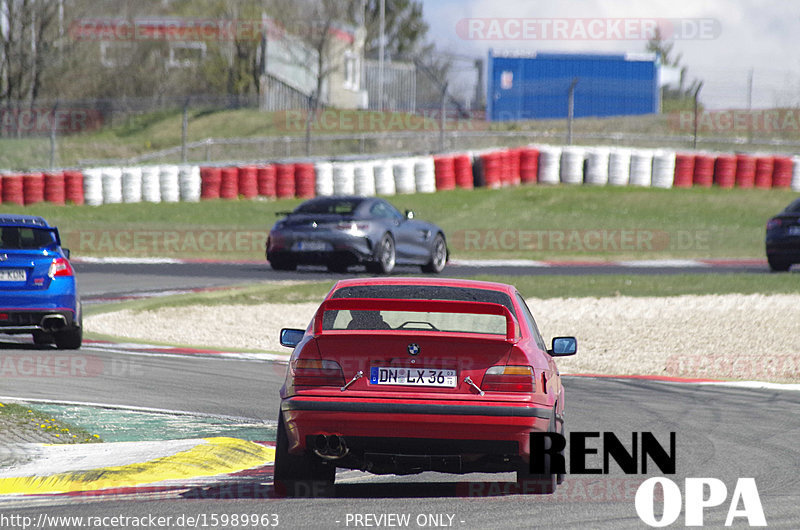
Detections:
275,278,577,496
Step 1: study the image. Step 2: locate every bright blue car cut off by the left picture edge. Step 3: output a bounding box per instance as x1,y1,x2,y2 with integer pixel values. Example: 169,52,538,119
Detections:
0,214,83,350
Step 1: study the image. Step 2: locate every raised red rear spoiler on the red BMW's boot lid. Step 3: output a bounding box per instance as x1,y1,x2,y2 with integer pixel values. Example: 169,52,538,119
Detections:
313,298,517,342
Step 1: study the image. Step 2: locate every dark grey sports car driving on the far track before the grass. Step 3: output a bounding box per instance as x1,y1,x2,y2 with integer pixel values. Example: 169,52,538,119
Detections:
266,196,448,274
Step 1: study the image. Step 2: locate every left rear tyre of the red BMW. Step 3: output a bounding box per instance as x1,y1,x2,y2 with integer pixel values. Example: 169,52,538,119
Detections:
273,413,336,497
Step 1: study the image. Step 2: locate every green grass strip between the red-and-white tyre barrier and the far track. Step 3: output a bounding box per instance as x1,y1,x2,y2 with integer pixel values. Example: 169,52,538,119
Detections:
2,185,797,261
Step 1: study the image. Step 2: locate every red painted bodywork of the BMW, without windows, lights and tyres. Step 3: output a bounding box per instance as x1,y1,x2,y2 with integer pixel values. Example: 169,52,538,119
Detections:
281,278,564,472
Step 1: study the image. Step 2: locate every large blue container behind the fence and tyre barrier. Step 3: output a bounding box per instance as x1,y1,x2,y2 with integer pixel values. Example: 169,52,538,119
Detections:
486,51,661,121
